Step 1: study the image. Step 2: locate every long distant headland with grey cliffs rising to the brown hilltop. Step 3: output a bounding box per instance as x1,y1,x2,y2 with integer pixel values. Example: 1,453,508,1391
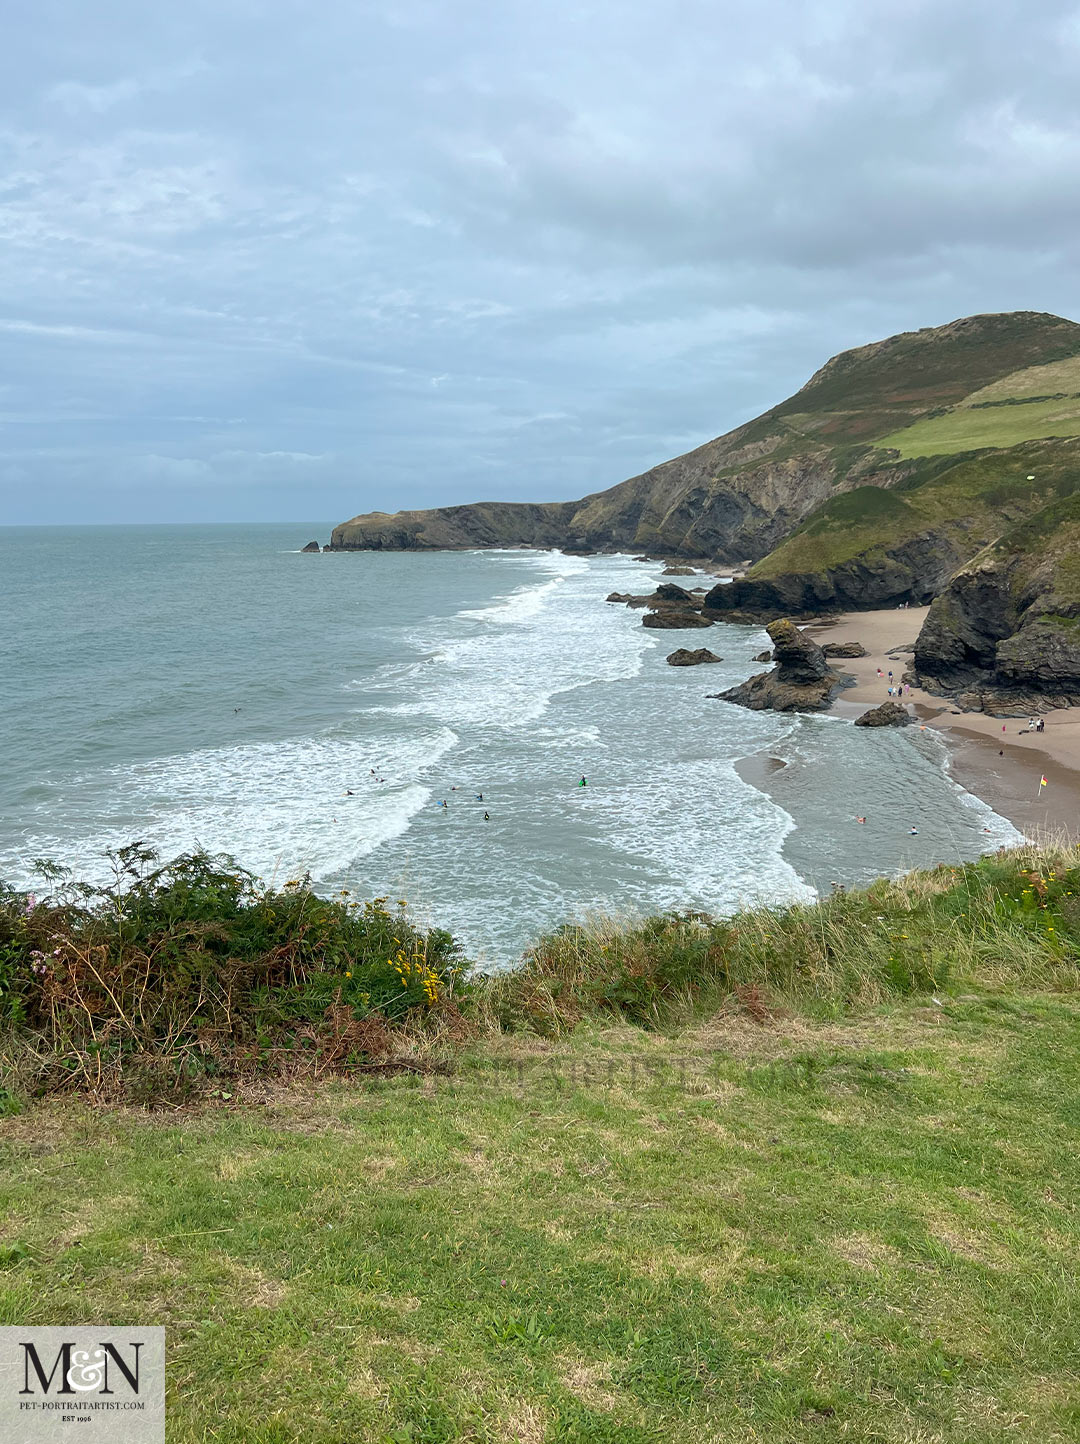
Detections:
331,312,1080,560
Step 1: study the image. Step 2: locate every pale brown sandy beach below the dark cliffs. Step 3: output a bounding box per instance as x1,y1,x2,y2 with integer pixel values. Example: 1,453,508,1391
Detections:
806,606,1080,836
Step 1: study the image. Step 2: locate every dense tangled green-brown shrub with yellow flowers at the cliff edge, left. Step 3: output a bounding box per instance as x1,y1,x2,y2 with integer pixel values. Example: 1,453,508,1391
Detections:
0,845,465,1095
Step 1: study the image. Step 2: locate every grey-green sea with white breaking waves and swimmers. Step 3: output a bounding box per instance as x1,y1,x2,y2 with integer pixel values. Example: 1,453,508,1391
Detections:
0,523,1018,965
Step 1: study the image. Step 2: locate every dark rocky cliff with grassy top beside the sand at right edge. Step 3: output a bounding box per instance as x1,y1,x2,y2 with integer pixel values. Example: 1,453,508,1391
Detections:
915,491,1080,710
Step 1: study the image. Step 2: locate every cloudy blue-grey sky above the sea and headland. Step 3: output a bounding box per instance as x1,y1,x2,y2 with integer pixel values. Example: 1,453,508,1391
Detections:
0,0,1080,526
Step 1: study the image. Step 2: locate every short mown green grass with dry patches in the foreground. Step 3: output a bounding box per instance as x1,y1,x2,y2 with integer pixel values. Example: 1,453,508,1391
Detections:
0,995,1080,1444
